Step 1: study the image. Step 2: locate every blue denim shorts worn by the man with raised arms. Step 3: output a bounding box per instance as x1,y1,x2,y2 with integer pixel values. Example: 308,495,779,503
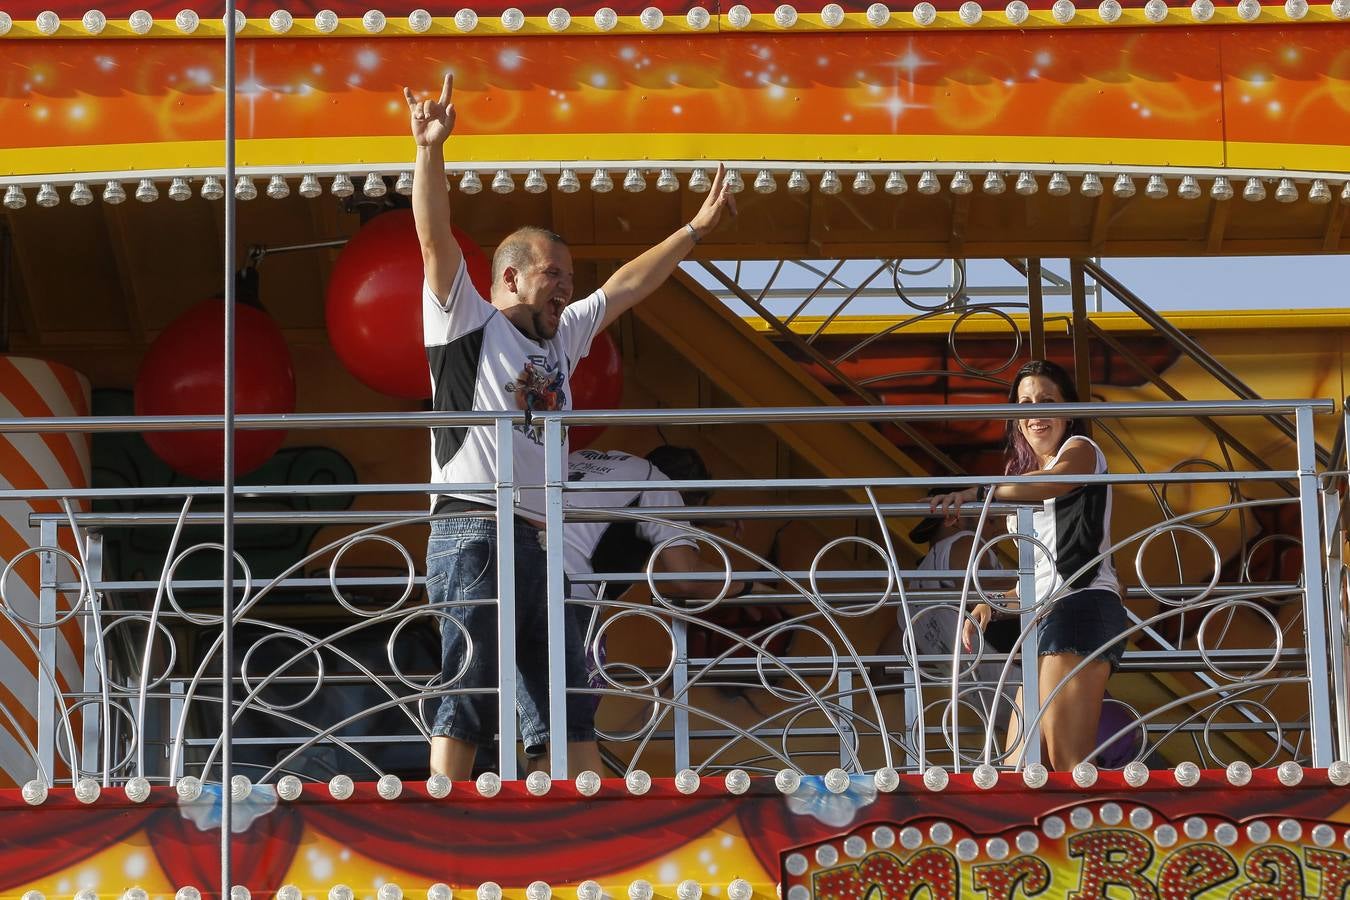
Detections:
427,518,595,756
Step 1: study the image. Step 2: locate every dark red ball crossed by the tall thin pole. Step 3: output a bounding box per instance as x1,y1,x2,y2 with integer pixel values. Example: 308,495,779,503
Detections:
135,300,296,482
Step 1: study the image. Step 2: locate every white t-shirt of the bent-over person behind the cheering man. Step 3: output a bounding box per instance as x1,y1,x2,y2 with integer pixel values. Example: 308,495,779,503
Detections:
563,449,695,599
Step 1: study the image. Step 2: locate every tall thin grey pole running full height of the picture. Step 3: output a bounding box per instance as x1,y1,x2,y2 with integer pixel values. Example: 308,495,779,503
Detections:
220,0,238,885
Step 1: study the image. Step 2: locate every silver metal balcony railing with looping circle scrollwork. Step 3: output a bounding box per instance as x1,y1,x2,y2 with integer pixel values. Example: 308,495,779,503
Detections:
0,401,1350,785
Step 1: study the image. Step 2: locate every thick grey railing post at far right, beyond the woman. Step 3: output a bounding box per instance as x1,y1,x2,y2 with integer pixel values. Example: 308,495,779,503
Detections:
1295,406,1337,769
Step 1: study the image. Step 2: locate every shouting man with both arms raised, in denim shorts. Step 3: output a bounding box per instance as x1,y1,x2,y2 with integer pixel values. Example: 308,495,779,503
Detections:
404,76,736,780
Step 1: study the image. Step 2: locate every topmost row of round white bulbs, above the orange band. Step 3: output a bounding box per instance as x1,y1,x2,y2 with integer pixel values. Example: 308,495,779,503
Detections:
0,0,1350,36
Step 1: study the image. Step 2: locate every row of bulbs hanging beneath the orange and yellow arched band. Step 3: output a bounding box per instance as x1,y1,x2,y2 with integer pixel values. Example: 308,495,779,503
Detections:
3,169,1350,209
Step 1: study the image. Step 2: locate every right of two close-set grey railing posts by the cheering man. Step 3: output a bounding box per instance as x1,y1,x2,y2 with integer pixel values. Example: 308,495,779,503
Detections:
544,417,567,779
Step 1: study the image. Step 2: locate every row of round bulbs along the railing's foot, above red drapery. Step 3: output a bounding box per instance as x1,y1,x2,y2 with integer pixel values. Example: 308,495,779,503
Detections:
23,760,1350,806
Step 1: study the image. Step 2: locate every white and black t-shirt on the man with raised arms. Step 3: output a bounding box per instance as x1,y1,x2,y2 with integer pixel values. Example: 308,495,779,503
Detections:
423,260,605,522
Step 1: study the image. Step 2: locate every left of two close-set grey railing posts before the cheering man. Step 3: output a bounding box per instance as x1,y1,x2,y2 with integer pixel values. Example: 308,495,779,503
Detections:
494,418,516,780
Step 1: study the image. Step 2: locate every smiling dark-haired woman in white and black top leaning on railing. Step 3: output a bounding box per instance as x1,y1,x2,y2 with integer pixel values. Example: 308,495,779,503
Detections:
932,359,1127,770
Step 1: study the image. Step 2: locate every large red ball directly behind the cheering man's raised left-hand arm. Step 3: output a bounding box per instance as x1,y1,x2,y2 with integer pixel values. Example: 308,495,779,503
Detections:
325,209,493,399
